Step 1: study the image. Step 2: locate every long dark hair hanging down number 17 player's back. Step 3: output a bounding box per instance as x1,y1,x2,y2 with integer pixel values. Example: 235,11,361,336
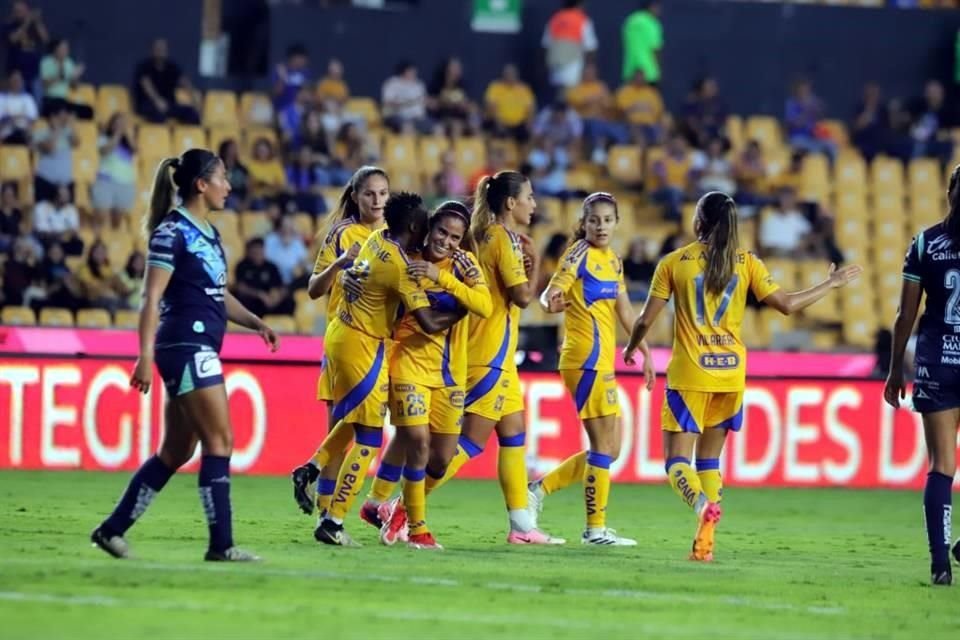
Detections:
695,191,740,294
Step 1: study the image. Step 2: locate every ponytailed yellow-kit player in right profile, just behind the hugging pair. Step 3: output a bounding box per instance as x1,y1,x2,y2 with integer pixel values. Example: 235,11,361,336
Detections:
418,171,564,544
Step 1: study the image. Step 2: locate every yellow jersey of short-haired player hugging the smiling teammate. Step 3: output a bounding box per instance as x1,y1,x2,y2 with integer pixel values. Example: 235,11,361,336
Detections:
336,229,430,340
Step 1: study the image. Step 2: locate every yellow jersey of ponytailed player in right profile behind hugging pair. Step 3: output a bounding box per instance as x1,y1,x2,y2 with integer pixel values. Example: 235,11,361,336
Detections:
468,223,527,371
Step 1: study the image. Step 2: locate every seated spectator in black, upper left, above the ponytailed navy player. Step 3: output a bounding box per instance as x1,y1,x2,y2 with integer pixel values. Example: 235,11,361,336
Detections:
133,38,200,124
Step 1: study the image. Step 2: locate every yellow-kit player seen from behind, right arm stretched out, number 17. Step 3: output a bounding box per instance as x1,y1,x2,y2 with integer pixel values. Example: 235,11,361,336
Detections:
623,191,861,561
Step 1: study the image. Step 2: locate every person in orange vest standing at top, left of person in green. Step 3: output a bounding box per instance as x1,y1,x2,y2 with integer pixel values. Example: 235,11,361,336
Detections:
540,0,599,95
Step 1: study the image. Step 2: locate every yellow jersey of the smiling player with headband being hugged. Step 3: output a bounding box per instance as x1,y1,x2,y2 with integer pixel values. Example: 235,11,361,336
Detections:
390,252,492,389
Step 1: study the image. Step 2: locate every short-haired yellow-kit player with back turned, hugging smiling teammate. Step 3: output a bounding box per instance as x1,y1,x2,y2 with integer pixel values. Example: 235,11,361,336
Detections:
314,193,458,546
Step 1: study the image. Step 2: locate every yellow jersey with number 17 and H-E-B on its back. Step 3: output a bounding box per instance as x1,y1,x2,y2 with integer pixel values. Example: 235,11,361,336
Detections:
650,242,780,393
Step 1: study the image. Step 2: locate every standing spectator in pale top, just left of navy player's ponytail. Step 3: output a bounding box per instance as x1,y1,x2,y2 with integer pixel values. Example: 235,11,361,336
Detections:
91,112,137,229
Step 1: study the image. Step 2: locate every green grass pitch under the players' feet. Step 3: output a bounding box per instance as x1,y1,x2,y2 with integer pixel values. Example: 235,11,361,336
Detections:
0,472,960,640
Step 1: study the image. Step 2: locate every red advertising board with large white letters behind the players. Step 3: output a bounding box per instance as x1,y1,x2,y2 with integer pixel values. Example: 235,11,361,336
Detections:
0,356,948,488
